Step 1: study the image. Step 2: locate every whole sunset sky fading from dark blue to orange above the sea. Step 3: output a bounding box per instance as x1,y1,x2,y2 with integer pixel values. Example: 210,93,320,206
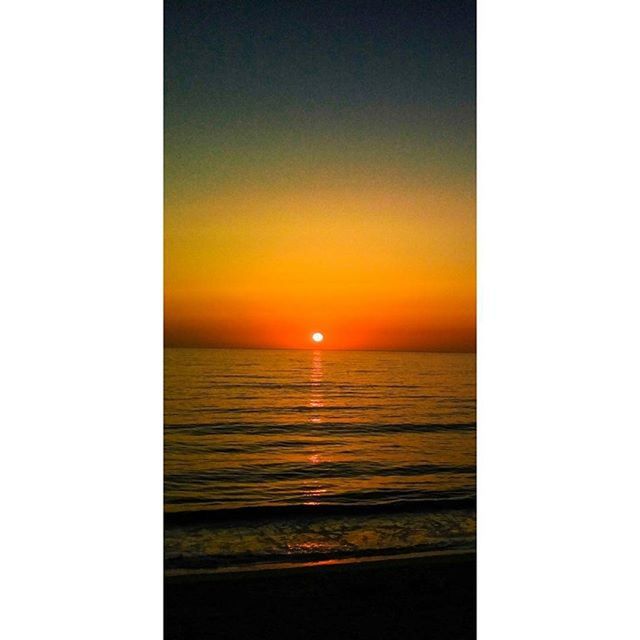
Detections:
165,0,476,351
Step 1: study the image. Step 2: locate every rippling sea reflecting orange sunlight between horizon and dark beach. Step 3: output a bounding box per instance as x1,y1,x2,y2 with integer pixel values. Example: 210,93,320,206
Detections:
165,349,475,570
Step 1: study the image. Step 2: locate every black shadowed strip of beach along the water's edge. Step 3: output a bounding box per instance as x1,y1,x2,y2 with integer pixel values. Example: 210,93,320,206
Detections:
165,554,476,640
